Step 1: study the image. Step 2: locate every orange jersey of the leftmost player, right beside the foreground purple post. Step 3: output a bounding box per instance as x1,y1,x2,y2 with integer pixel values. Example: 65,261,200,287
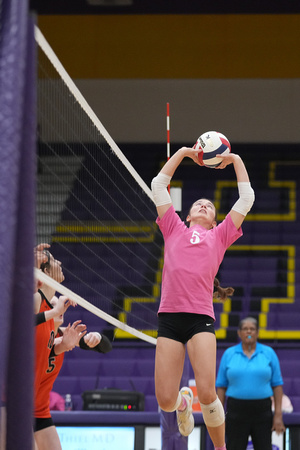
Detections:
34,291,54,414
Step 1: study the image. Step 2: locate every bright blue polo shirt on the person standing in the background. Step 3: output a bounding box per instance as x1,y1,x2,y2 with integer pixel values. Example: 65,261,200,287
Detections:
216,343,283,400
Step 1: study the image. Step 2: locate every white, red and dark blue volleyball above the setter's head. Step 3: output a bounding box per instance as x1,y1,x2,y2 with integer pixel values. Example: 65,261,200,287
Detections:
193,131,231,168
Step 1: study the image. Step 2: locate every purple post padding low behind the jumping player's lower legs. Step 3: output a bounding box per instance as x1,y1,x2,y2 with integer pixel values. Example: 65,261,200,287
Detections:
160,411,188,450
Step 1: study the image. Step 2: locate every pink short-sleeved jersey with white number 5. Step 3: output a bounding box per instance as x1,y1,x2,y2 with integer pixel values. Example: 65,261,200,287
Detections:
156,206,243,320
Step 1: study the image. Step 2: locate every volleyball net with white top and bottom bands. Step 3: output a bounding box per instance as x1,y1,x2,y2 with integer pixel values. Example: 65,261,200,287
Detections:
35,28,163,344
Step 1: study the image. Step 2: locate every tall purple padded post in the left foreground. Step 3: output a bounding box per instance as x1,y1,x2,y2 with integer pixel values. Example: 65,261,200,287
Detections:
0,0,36,450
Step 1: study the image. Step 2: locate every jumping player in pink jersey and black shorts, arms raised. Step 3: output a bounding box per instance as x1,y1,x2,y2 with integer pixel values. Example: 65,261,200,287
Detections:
151,147,254,450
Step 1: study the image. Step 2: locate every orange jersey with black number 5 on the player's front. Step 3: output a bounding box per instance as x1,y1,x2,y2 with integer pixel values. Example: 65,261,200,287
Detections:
34,329,64,418
